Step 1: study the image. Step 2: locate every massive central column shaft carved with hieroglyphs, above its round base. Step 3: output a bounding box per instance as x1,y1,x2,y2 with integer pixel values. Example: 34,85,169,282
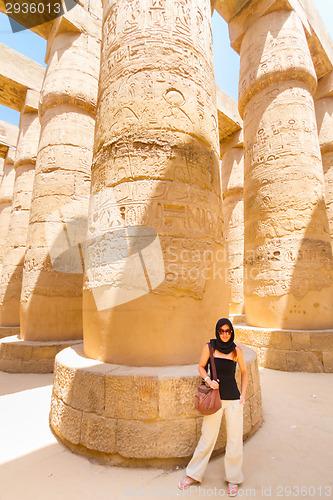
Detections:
83,0,227,365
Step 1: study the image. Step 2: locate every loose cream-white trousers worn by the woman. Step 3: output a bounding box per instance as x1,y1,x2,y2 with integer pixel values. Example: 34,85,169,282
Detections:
186,399,243,484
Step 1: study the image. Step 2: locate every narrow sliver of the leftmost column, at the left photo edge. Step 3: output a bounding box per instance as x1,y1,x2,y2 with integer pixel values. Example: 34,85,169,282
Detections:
0,147,16,276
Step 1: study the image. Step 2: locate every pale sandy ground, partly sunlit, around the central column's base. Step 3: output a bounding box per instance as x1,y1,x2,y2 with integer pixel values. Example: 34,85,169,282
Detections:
0,369,333,500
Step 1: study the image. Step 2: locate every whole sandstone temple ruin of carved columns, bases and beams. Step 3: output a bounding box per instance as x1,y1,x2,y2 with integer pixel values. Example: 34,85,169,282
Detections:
0,0,333,466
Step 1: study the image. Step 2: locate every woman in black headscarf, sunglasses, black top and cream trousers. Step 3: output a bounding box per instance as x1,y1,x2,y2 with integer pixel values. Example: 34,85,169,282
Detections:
178,318,247,496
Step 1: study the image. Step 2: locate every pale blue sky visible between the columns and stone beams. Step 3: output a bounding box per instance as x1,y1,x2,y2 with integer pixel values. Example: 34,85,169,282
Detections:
0,0,333,125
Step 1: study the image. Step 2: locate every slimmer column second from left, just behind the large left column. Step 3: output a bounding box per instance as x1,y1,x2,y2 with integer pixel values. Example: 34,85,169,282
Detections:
0,90,40,326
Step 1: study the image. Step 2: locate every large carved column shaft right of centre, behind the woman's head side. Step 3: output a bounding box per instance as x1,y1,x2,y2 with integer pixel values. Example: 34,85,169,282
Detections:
239,11,333,329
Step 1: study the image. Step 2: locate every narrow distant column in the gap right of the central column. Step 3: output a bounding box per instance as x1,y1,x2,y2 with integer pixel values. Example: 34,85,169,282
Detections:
222,147,244,314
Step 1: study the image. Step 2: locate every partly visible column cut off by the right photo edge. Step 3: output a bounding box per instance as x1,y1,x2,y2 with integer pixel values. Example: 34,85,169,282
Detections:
315,72,333,245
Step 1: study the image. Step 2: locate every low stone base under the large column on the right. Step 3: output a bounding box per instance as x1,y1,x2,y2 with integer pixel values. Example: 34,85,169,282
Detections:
235,324,333,373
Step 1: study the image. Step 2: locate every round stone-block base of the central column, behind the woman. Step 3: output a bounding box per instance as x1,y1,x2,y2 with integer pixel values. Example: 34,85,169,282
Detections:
50,345,262,467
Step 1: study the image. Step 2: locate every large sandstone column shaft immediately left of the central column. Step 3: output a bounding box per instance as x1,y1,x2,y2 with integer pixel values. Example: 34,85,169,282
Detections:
21,25,99,341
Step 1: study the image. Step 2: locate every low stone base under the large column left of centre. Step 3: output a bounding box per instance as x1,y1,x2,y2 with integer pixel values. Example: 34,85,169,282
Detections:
0,335,83,373
